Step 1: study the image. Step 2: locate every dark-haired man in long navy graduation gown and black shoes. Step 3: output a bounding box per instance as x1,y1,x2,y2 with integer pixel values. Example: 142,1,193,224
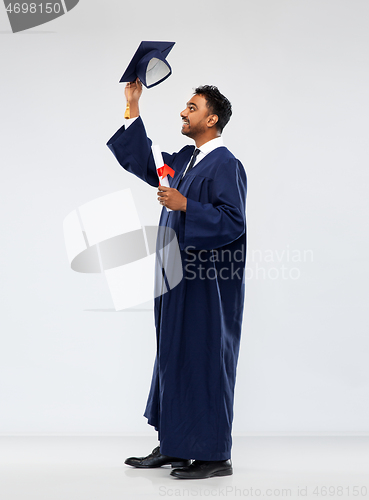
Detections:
108,79,246,479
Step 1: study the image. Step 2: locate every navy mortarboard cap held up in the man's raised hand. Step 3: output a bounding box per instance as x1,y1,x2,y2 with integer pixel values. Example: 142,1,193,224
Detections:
120,42,175,89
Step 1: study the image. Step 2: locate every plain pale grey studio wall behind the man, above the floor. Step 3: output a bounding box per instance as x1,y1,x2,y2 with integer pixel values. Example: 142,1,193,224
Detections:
0,0,369,434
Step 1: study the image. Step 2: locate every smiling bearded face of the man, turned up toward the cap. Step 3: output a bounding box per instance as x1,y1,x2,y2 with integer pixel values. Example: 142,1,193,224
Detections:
180,94,210,139
